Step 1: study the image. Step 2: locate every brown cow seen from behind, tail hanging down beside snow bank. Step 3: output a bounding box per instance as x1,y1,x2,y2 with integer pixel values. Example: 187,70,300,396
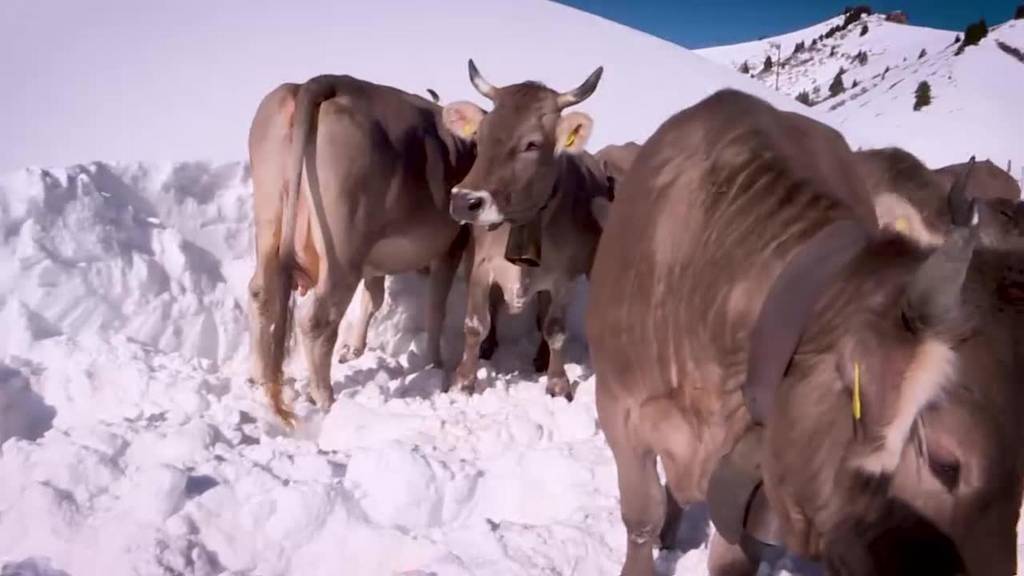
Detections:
249,75,474,423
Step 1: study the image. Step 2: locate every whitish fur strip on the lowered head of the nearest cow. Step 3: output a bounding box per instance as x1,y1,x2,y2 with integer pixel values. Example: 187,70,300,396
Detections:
854,339,956,476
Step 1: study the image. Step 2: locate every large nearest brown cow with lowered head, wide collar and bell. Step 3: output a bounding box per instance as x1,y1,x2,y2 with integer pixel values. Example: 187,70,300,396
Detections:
587,90,1024,576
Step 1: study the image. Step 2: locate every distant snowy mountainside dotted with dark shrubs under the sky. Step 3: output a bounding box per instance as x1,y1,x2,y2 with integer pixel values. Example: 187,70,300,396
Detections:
697,14,1024,178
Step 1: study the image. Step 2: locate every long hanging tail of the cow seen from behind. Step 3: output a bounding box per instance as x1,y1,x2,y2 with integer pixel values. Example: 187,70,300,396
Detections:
266,79,331,427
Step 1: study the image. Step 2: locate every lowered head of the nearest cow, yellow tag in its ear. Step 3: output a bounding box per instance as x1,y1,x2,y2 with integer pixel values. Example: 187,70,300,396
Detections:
769,186,1024,575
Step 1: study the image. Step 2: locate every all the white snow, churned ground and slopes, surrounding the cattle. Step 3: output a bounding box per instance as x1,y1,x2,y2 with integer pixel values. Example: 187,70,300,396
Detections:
0,0,1024,576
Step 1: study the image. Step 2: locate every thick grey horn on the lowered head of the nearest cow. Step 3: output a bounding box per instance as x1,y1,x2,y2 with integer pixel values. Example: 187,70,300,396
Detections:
903,224,977,333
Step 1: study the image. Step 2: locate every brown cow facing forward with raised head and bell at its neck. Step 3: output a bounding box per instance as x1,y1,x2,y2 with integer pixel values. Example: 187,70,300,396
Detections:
444,60,607,398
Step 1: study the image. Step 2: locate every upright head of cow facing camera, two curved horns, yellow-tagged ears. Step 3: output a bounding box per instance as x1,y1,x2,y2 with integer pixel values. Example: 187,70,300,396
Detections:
443,60,602,225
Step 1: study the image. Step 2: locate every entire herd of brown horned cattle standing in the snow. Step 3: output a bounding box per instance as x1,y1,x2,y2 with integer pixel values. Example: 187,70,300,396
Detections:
249,60,1024,576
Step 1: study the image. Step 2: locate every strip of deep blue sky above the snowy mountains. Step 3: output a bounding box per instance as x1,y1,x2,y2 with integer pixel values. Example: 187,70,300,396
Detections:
559,0,1021,48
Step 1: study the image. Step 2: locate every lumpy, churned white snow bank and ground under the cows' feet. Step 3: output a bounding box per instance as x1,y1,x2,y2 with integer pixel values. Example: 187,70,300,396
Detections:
0,157,659,576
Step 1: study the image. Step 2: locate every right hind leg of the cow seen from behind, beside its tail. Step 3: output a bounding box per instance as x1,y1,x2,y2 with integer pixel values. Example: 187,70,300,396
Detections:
298,271,359,411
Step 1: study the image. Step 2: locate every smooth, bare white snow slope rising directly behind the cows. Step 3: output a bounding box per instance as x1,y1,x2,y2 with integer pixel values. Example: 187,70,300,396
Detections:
0,0,815,170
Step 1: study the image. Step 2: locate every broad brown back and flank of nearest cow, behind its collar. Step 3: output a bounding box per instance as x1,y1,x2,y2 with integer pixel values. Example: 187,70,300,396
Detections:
588,90,876,403
